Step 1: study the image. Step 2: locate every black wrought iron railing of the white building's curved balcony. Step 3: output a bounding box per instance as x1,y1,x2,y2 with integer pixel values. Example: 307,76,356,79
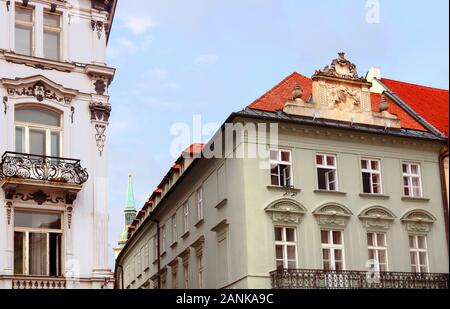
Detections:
0,152,89,185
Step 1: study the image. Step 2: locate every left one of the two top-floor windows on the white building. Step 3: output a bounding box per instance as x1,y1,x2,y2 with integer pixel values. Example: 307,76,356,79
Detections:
15,6,34,56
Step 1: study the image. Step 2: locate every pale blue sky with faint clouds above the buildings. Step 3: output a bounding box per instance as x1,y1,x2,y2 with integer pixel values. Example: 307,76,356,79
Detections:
104,0,449,264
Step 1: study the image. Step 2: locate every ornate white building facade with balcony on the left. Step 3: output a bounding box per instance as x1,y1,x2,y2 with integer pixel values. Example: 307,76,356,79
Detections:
0,0,116,289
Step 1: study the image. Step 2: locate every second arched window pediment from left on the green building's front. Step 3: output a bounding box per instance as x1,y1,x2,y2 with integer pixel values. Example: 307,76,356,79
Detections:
313,203,353,228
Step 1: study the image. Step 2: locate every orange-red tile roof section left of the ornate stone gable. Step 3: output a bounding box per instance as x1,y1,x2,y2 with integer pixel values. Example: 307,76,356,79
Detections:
248,72,312,112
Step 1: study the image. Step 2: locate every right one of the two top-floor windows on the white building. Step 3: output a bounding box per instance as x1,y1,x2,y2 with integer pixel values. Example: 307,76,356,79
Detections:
44,12,61,61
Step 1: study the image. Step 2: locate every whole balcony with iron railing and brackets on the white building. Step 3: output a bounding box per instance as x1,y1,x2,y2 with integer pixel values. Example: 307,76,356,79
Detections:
0,152,89,204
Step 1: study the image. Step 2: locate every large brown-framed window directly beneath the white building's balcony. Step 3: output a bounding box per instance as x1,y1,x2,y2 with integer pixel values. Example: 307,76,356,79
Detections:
14,210,63,277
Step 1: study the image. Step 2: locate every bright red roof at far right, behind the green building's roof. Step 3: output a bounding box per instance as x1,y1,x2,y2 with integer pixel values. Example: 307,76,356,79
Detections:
381,78,448,136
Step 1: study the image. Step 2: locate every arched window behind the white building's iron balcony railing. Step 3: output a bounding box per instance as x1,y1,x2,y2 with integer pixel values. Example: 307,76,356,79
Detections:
15,105,62,157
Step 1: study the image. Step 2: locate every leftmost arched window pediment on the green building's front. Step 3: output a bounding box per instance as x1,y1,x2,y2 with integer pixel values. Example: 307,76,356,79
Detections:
264,199,306,224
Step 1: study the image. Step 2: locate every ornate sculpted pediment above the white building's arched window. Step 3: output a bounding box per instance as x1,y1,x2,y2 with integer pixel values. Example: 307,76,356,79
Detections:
0,75,78,105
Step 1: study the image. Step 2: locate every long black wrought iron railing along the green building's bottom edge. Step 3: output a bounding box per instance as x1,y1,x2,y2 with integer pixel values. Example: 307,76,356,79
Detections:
270,269,448,289
